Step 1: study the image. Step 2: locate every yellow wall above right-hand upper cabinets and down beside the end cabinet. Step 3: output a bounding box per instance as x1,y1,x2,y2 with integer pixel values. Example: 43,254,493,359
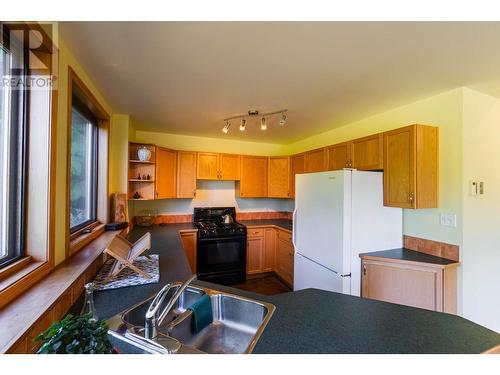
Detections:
287,88,462,245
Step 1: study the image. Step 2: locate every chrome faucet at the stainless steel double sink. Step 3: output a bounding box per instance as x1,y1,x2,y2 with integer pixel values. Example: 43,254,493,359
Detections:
144,275,196,339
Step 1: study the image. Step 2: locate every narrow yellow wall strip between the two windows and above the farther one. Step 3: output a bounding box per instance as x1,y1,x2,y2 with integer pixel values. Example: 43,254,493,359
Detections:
55,38,115,265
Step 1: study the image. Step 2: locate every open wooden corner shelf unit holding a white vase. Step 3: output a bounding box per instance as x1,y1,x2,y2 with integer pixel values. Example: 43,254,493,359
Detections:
128,142,156,201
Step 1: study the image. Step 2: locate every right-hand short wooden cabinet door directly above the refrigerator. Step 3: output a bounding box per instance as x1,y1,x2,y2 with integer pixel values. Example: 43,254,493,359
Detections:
351,133,384,171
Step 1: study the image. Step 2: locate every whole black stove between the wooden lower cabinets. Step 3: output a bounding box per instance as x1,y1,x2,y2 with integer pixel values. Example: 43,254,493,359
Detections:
193,207,247,285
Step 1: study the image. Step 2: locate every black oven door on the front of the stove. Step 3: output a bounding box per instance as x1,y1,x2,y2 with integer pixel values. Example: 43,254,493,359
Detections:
196,236,247,282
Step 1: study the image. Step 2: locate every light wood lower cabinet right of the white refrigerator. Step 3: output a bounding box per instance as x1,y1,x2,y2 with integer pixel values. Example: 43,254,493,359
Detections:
361,256,458,314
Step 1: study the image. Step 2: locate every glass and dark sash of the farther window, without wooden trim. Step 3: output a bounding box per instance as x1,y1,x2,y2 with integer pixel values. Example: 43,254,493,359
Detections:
70,104,98,233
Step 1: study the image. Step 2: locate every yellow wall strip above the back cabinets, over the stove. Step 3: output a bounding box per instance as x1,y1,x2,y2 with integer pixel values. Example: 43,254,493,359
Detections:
135,130,286,155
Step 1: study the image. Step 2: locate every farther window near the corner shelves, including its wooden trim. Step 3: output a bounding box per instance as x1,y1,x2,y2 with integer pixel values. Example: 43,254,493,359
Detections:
66,67,109,257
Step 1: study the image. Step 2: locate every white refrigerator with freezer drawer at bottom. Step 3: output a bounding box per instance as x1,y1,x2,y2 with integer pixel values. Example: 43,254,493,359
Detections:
292,169,403,296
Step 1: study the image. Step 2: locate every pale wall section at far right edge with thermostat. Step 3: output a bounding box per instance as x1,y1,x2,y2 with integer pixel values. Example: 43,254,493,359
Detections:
461,89,500,332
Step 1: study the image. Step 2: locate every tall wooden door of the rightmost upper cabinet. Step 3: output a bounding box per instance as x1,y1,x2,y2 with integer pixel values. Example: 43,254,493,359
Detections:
384,126,415,208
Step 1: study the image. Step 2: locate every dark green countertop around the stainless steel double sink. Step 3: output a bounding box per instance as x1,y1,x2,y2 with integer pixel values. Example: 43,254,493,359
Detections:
95,224,500,353
